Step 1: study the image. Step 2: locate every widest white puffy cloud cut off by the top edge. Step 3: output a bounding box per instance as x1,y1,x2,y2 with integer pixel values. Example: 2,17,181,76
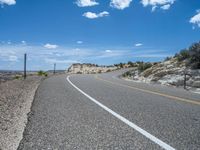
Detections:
141,0,176,11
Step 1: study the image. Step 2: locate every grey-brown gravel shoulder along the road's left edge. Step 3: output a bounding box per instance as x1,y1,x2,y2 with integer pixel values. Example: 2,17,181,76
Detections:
0,76,43,150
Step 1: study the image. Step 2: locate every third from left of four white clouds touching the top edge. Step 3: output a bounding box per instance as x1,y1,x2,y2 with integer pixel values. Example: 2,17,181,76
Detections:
110,0,132,10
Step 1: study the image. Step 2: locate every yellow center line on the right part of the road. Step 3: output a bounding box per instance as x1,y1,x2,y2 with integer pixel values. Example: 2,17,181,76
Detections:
95,75,200,105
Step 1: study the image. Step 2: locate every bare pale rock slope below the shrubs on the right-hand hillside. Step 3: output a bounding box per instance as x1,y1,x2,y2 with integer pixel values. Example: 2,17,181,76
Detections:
124,58,200,88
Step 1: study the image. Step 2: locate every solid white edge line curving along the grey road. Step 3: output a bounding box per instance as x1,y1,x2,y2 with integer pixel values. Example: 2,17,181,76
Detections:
66,76,175,150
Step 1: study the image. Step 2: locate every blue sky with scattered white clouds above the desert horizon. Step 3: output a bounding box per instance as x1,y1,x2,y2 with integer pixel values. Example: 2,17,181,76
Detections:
0,0,200,70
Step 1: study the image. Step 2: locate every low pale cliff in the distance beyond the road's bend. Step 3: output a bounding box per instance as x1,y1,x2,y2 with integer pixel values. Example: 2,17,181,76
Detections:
68,64,117,74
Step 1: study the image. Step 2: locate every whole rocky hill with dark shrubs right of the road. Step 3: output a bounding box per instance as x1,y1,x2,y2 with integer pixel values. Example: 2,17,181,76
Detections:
123,42,200,88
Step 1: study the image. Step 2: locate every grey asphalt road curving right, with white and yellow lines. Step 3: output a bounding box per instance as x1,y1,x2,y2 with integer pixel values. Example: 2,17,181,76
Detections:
18,71,200,150
